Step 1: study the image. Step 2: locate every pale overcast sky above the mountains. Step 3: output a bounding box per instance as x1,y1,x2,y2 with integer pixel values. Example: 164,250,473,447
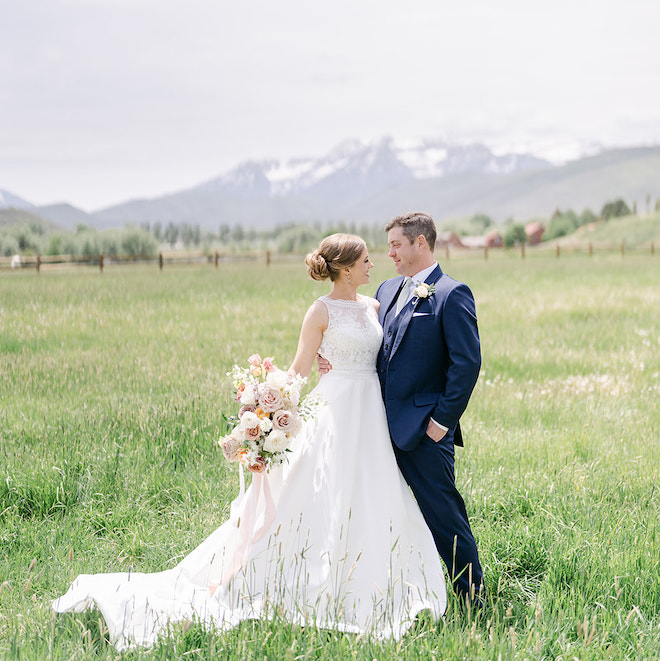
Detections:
0,0,660,211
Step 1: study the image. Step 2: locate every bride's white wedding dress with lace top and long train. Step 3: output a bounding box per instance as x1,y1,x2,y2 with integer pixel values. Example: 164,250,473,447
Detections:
53,296,446,650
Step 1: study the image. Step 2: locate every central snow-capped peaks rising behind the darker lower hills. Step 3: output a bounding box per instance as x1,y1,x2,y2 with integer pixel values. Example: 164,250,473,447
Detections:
199,138,551,199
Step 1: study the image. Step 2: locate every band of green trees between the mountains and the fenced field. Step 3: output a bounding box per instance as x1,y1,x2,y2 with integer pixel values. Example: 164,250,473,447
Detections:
0,199,660,259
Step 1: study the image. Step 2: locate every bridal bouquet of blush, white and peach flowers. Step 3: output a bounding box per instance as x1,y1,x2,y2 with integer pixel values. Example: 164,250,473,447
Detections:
219,354,316,473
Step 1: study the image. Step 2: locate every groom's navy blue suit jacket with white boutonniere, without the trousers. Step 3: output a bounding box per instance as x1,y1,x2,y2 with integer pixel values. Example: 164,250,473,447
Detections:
376,266,481,450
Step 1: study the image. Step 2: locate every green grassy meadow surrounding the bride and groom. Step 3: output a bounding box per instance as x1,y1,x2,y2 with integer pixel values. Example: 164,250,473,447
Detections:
0,253,660,660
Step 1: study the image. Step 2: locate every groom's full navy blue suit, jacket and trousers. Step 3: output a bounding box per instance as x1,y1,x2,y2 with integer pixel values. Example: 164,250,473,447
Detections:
376,266,483,595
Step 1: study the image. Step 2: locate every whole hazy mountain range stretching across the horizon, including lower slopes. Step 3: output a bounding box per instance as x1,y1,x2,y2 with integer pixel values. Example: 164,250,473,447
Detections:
0,138,660,231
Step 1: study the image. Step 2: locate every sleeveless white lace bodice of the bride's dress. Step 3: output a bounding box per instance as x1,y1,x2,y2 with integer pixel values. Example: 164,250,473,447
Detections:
319,296,383,372
